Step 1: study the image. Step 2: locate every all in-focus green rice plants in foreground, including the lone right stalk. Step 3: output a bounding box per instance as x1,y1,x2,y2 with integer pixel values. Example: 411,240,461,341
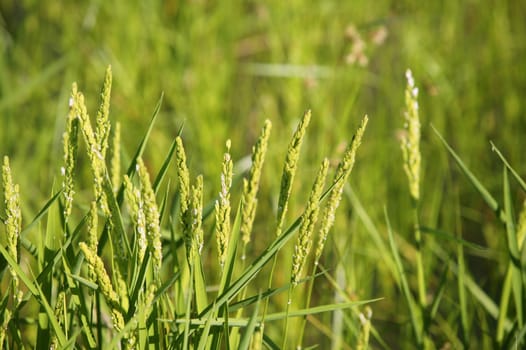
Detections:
0,64,526,349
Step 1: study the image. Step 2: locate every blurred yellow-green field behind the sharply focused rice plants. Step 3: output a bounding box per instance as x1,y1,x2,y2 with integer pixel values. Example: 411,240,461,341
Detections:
0,0,526,348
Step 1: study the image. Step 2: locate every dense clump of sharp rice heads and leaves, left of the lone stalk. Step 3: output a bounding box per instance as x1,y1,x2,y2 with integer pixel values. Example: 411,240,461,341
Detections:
0,68,378,349
